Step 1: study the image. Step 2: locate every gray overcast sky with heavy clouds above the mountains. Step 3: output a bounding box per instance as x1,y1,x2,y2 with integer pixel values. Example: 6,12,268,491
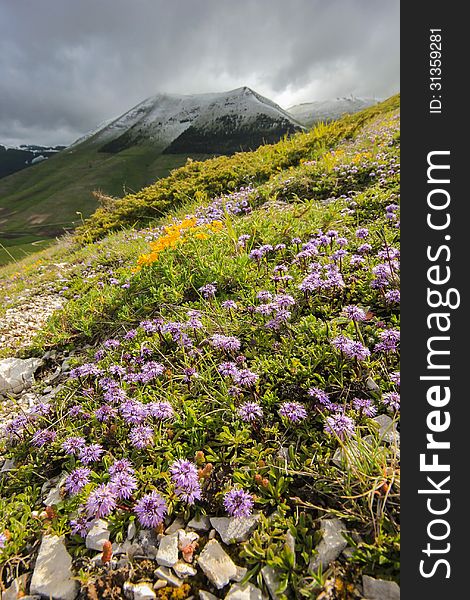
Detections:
0,0,399,144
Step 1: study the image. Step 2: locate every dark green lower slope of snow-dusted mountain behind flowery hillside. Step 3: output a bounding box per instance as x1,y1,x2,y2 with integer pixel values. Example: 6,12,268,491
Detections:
0,143,206,264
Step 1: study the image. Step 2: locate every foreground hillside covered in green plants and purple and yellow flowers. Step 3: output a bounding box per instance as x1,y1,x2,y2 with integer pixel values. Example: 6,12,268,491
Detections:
0,96,400,600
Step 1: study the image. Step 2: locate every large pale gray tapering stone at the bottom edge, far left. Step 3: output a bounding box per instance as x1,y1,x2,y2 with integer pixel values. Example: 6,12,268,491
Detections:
29,535,80,600
